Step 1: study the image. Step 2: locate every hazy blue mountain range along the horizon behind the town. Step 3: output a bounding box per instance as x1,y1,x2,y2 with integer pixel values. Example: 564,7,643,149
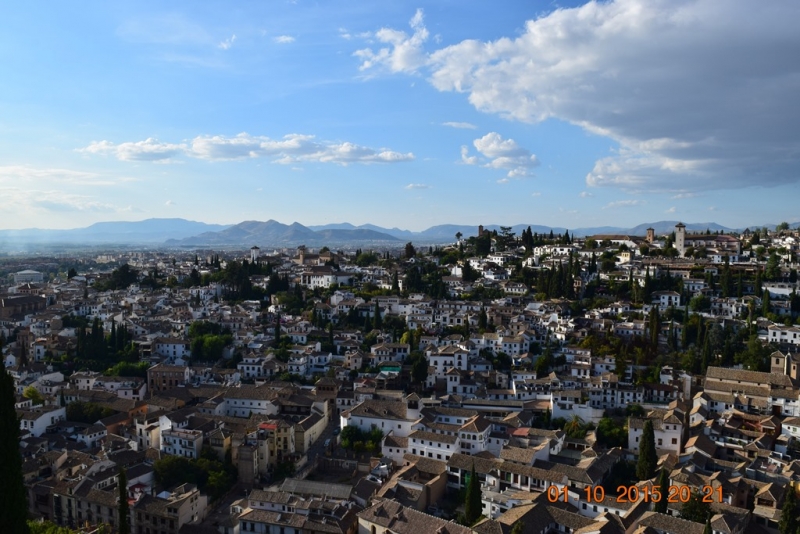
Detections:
0,219,797,247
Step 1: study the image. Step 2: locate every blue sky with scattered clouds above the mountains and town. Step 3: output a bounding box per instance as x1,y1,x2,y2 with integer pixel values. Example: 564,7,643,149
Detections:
0,0,800,231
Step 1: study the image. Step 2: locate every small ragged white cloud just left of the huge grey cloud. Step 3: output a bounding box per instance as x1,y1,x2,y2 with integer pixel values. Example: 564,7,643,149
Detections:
353,9,428,72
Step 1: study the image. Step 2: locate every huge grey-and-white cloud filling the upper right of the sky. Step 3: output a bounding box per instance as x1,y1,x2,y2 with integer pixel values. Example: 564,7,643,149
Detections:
360,0,800,192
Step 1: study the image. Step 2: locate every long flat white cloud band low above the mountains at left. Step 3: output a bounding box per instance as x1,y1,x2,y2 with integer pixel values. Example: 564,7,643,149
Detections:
80,133,414,165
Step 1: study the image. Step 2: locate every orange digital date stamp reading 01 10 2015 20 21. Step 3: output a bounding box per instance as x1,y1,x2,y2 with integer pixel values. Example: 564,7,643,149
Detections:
547,486,723,504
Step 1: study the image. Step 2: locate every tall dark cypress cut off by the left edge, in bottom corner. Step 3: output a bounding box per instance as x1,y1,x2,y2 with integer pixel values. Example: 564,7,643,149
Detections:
0,370,29,534
